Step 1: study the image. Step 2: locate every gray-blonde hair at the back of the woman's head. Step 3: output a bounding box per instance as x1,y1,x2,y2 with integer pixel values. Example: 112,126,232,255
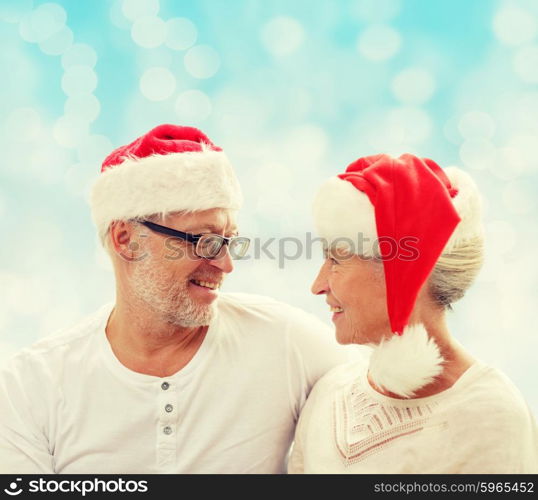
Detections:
429,236,484,309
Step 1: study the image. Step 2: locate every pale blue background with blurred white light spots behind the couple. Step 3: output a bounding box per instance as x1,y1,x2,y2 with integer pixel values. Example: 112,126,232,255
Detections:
0,0,538,413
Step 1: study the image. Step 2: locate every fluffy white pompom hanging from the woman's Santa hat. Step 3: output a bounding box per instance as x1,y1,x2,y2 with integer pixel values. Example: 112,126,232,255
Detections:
368,324,444,398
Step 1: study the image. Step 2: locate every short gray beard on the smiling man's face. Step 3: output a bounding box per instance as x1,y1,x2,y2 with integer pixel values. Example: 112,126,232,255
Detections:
131,258,216,327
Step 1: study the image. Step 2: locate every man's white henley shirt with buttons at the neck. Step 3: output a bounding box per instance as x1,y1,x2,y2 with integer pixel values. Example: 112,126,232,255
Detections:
0,293,348,474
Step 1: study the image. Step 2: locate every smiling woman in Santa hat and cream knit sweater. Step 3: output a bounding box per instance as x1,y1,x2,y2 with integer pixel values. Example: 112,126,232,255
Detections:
289,155,538,474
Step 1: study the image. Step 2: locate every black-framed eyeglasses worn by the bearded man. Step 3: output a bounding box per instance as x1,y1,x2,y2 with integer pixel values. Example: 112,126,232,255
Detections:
139,220,250,259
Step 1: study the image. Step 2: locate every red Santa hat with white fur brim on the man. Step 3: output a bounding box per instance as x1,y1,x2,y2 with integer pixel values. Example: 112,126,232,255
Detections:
90,125,243,240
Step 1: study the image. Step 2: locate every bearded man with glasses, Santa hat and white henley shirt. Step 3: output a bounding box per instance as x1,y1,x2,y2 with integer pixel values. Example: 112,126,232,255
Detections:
0,125,343,473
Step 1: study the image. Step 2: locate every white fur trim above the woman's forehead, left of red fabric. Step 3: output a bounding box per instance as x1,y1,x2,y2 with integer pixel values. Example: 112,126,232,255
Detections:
313,177,377,257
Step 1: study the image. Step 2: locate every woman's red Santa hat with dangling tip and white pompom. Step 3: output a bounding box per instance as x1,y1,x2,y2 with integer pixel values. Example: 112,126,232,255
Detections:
314,154,483,397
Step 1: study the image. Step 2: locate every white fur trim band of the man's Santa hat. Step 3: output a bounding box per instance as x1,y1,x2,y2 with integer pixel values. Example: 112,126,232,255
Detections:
90,148,243,238
